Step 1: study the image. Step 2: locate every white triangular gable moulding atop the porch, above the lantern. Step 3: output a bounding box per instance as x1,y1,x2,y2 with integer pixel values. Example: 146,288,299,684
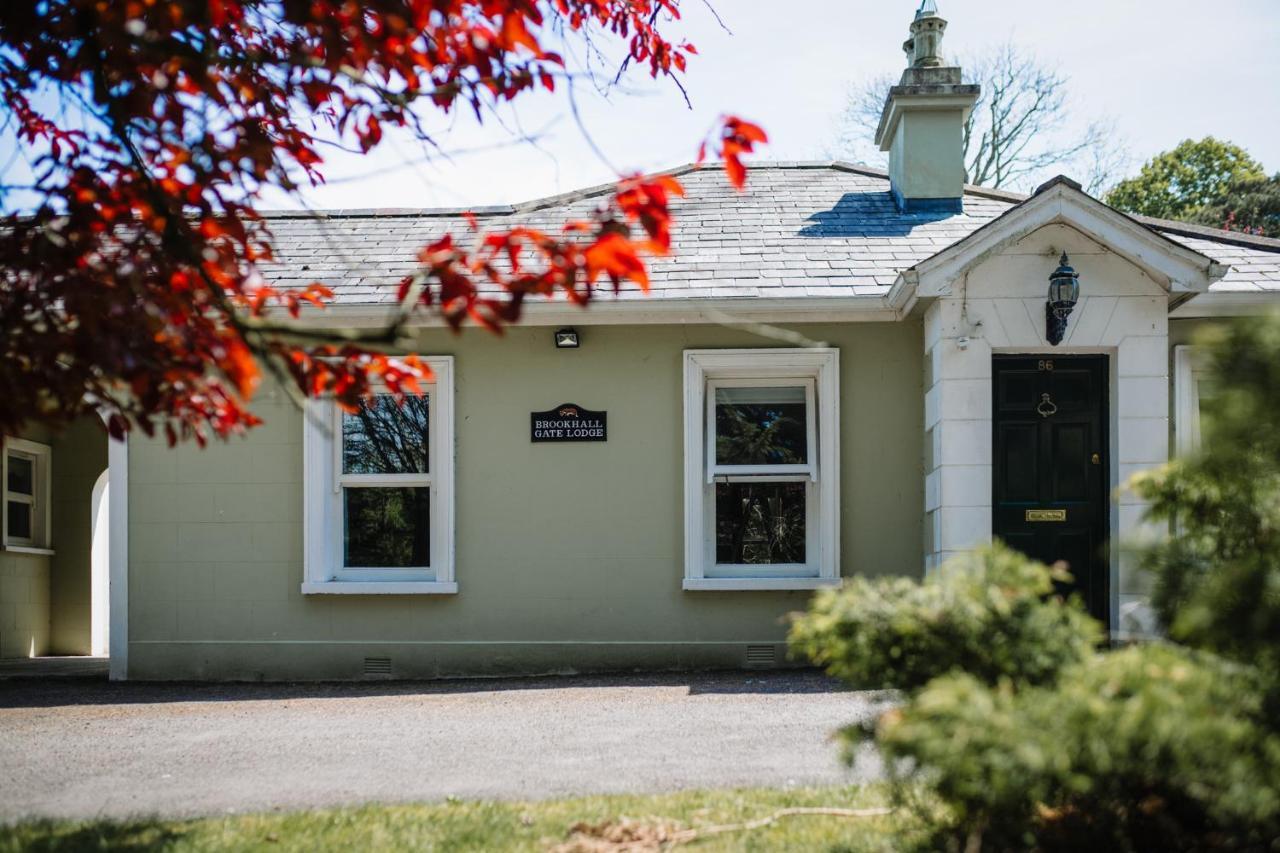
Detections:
890,177,1229,314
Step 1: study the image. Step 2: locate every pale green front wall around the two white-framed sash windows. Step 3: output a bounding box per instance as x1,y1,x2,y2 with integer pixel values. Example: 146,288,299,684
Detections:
129,323,923,679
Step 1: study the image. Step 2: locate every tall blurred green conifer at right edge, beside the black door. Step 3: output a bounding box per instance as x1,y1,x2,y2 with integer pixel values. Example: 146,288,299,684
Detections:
1134,316,1280,686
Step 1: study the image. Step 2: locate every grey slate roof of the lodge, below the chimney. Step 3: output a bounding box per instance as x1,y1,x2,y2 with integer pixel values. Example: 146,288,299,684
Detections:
262,163,1280,305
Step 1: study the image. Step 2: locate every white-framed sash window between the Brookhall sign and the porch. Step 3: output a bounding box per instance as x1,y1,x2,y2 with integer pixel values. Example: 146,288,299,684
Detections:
685,350,838,589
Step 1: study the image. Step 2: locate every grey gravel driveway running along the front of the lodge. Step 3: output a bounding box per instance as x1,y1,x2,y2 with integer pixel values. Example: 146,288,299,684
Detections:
0,672,877,821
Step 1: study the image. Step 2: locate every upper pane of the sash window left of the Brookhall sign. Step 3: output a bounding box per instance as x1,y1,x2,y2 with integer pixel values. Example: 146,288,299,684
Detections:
342,394,430,474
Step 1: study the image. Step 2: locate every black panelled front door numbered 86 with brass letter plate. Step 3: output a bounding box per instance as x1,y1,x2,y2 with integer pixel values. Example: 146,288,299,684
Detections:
992,356,1111,625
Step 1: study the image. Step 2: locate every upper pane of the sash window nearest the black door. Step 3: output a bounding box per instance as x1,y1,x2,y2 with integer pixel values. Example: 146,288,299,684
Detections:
716,386,809,465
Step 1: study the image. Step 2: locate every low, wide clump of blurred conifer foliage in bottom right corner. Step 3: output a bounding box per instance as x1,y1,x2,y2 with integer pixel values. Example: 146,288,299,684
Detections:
876,644,1280,850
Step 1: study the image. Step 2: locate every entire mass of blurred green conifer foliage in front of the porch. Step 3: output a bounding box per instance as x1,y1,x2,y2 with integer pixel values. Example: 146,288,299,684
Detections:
791,318,1280,853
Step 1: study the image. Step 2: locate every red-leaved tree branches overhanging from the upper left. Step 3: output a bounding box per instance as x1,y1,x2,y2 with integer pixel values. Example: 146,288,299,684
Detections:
0,0,764,442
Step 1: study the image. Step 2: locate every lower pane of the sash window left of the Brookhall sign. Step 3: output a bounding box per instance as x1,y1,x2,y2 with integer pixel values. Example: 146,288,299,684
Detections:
343,488,431,569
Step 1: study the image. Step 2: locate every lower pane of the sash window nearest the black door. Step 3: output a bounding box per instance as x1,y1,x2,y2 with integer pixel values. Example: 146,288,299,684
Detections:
716,483,805,565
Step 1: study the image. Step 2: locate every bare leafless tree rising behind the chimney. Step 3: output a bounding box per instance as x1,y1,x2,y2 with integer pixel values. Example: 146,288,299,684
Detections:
835,42,1125,193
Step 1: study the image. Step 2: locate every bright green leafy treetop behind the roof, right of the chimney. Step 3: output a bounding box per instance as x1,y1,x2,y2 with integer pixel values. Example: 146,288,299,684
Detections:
1106,136,1266,219
